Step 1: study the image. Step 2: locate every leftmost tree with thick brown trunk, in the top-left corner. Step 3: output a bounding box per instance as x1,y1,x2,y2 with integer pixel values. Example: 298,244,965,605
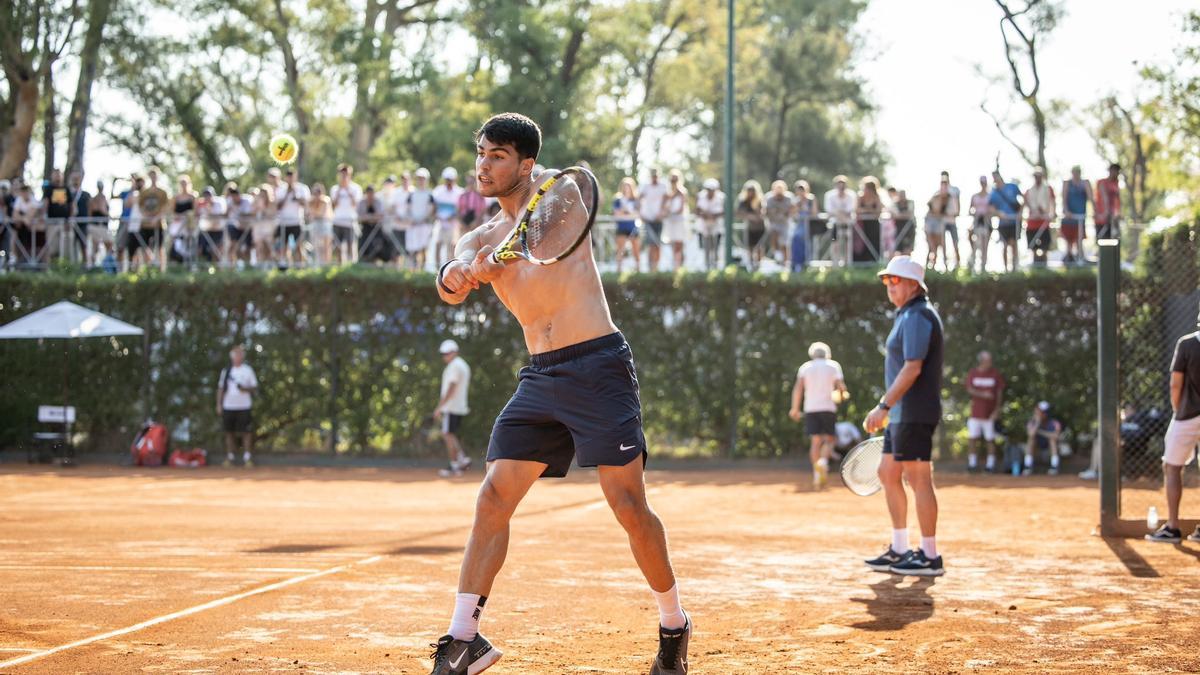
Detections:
0,0,79,177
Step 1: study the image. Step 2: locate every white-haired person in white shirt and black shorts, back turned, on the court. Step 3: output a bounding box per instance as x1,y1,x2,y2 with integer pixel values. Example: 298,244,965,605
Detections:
788,342,850,490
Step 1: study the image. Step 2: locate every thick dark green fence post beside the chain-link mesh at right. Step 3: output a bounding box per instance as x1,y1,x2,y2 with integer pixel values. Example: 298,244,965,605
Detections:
1096,239,1121,537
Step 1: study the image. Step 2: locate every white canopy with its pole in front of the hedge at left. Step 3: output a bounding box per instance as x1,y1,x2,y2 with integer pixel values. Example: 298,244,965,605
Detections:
0,300,144,461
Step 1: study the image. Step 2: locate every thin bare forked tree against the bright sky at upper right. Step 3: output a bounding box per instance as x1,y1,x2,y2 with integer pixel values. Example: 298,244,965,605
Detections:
979,0,1064,167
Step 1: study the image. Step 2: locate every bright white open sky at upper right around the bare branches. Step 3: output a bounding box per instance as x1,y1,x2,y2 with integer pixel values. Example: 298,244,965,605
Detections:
859,0,1194,202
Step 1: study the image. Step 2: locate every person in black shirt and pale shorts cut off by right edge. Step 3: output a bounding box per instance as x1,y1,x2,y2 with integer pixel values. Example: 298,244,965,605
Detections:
1146,305,1200,544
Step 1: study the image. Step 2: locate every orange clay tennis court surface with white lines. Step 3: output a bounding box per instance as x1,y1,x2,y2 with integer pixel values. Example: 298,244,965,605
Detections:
0,465,1200,675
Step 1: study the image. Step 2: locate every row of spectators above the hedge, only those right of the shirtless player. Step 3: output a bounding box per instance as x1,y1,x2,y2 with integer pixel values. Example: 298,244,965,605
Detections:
613,165,1121,273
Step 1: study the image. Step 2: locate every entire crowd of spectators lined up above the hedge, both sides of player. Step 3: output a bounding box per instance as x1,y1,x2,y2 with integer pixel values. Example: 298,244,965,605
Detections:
0,158,1121,271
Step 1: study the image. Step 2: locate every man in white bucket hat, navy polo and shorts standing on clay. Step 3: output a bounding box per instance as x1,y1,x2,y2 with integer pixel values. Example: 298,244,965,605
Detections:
863,256,944,577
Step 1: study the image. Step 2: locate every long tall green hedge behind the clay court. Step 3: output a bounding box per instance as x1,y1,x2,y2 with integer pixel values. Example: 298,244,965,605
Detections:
0,268,1096,456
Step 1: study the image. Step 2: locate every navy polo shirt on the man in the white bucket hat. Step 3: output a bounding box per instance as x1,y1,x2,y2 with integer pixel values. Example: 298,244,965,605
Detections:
883,295,942,424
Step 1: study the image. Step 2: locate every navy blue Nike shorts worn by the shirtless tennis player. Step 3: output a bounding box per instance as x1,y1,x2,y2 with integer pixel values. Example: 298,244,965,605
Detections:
487,333,647,478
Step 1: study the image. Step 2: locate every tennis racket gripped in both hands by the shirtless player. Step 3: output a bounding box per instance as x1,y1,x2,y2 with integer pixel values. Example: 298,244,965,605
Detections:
492,167,600,265
